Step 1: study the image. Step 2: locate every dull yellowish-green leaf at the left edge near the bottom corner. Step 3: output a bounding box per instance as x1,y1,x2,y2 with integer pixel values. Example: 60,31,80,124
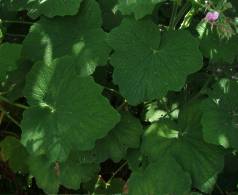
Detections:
0,137,28,173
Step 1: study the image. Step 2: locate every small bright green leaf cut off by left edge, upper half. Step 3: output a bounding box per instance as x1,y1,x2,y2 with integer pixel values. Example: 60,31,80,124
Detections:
0,43,22,81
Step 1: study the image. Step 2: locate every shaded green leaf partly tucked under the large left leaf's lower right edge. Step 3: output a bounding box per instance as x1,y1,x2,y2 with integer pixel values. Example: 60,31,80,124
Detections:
93,113,143,162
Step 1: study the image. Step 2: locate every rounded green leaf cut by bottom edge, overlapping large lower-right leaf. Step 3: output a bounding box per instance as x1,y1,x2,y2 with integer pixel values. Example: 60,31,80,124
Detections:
128,156,191,195
